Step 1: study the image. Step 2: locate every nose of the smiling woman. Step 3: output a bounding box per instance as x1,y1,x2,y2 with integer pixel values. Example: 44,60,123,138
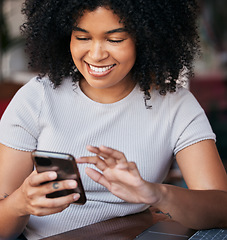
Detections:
89,41,109,62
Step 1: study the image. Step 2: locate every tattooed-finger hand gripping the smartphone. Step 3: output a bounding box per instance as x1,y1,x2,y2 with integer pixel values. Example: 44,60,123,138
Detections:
16,171,80,216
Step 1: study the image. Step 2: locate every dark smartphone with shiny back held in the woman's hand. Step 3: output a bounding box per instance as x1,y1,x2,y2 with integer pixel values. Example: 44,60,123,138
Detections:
32,150,86,205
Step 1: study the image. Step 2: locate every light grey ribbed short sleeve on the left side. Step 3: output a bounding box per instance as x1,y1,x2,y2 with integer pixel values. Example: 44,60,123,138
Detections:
0,78,43,151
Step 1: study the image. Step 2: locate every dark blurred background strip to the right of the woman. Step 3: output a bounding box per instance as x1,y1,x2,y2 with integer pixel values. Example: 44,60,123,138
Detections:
190,0,227,168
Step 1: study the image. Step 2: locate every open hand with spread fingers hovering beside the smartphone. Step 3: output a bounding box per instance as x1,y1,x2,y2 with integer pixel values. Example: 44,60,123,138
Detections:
77,146,160,204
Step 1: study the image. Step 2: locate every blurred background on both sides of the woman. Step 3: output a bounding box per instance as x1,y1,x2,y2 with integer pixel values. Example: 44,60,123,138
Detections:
0,0,227,169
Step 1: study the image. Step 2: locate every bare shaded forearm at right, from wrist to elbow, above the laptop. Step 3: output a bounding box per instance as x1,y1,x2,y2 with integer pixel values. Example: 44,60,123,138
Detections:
151,185,227,229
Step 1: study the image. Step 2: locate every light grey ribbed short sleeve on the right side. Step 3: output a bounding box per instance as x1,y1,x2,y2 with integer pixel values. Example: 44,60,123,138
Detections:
169,88,216,154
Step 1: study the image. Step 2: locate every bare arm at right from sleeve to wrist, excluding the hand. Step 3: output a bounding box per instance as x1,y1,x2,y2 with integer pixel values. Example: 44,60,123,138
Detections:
163,140,227,228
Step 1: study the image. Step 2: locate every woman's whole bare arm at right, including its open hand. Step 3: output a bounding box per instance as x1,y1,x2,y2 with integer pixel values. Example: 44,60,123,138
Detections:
77,140,227,229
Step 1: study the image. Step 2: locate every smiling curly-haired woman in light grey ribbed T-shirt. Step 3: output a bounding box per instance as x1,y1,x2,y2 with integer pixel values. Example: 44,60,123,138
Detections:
0,0,227,239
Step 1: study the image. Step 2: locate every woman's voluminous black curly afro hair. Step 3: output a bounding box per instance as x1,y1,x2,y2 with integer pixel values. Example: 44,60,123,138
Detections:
21,0,198,99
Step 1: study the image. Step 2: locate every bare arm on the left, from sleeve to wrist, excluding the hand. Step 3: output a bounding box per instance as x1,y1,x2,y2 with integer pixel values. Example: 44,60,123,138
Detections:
0,144,33,238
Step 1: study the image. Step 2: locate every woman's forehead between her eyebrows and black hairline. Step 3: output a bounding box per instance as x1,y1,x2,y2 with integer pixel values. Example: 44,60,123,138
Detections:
76,7,124,30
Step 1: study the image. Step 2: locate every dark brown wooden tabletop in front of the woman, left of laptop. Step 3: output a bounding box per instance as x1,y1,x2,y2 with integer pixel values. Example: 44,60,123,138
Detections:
44,208,174,240
